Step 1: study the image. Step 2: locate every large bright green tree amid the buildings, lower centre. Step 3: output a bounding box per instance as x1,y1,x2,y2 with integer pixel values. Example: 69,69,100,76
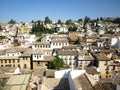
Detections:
47,57,64,70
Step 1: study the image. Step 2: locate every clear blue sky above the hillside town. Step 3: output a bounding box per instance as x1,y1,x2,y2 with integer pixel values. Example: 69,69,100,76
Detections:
0,0,120,22
